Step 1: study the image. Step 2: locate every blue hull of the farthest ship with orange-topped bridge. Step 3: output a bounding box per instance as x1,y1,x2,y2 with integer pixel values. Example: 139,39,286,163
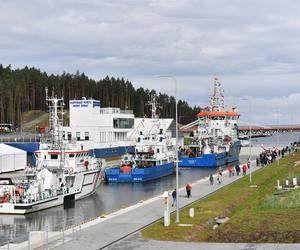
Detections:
178,141,241,168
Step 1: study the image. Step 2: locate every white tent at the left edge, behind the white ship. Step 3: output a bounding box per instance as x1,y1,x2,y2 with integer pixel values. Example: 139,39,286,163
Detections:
0,144,26,173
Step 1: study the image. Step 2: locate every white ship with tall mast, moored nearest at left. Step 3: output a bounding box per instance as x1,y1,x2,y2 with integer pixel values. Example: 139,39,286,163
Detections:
0,91,102,214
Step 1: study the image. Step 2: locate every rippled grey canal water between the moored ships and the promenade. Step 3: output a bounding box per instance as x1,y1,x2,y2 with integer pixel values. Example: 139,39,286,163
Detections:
0,132,300,245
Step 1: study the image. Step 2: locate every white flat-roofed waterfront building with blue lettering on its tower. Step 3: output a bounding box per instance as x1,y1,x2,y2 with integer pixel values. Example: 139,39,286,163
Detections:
62,97,135,158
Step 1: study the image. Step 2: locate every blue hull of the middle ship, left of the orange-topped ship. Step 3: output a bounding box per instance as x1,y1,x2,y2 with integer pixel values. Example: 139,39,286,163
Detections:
105,162,175,183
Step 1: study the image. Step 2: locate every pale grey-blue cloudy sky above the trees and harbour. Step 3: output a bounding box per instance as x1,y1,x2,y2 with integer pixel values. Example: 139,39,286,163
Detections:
0,0,300,125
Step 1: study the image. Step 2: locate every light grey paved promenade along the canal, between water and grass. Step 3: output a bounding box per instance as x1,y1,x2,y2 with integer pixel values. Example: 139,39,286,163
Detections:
1,148,300,250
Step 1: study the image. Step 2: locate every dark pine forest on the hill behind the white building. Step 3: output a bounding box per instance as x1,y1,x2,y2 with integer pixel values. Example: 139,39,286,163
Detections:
0,64,201,125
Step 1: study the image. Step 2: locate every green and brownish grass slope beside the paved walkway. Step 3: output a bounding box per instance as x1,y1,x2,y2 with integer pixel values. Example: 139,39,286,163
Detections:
142,153,300,243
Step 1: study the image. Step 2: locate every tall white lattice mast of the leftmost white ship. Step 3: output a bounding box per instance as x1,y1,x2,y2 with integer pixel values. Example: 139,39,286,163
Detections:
46,88,65,148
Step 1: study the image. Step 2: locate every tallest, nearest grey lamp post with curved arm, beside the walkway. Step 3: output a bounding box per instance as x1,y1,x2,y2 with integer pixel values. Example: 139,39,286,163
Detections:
159,75,179,223
